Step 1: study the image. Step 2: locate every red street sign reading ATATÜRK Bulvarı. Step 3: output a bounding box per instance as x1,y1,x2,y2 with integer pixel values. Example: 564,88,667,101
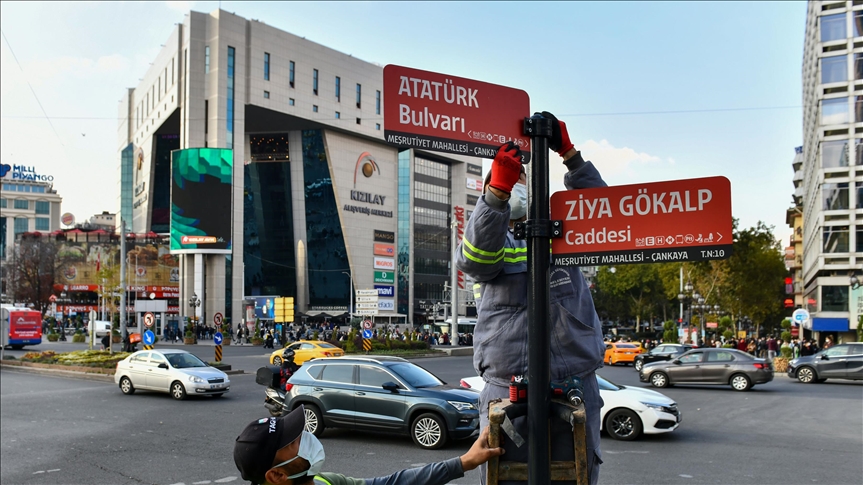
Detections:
384,64,530,161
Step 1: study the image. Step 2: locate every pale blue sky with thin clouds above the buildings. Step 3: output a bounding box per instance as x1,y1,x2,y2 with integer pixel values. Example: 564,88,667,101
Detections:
0,1,806,245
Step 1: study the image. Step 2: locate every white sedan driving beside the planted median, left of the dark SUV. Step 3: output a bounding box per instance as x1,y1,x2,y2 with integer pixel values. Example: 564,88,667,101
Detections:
114,349,231,400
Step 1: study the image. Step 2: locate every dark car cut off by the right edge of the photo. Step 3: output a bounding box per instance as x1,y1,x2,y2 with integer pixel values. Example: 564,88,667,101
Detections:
788,342,863,384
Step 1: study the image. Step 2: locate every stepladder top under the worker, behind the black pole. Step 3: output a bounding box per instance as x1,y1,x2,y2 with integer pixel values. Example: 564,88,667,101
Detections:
486,399,588,485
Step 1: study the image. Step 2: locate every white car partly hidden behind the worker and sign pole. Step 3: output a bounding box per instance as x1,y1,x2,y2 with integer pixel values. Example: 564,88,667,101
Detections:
460,374,681,441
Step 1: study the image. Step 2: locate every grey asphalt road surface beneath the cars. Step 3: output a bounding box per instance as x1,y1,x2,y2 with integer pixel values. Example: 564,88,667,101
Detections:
0,343,863,485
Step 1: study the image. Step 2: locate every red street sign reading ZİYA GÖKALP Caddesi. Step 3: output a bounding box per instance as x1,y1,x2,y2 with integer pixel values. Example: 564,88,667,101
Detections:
551,177,732,266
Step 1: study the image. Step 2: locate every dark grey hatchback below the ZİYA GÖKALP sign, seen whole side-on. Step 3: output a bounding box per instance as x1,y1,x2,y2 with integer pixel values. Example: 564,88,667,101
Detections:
638,348,773,391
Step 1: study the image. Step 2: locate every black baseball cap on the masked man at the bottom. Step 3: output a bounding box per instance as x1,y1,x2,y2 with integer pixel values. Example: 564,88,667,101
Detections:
234,405,306,483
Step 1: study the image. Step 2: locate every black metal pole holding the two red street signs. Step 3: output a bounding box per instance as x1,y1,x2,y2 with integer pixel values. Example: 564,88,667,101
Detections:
524,113,552,484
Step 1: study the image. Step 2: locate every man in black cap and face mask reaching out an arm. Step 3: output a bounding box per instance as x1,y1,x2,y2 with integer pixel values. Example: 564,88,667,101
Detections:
234,405,503,485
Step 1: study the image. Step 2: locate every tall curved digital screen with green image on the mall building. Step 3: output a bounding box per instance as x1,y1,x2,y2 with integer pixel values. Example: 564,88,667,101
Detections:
171,148,234,254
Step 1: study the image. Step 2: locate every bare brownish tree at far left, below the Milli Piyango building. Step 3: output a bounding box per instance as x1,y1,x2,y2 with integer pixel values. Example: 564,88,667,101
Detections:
9,234,66,314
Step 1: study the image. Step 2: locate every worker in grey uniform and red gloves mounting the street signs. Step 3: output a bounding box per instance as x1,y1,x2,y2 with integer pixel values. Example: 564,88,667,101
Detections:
457,112,607,485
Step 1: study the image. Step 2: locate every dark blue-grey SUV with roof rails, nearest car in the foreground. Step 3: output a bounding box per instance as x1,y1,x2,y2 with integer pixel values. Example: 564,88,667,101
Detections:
287,356,479,449
